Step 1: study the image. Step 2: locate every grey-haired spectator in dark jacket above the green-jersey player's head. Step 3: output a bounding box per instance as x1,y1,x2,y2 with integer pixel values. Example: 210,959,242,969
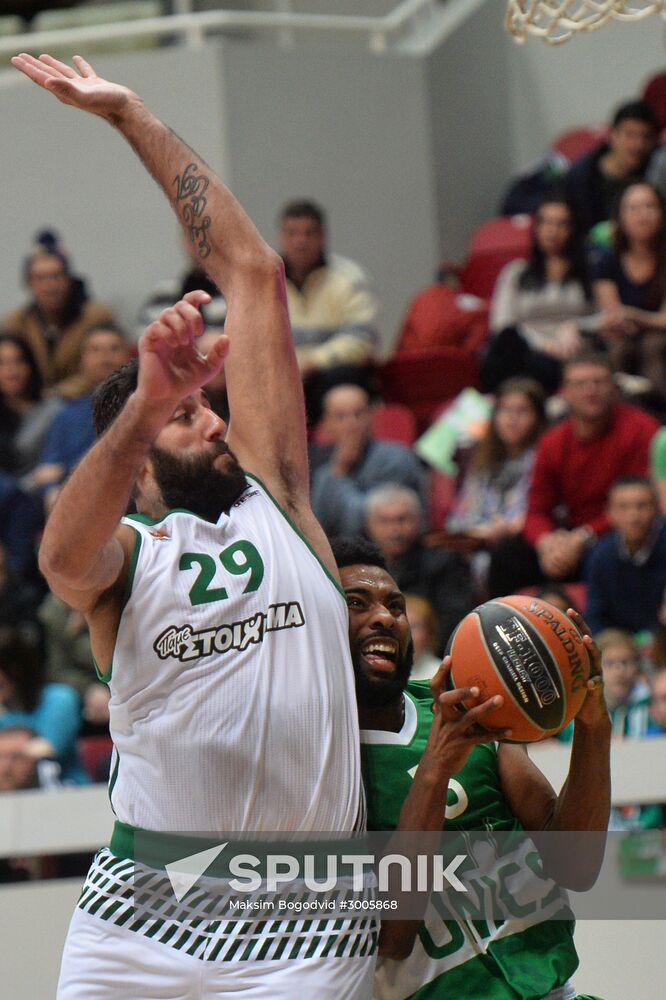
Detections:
365,483,476,651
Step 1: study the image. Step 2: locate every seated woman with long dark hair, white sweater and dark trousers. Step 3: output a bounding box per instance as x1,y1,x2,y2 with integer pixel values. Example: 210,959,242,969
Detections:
482,195,592,393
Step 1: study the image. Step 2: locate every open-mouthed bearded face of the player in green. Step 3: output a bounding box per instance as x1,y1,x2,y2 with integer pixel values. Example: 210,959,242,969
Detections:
340,565,414,708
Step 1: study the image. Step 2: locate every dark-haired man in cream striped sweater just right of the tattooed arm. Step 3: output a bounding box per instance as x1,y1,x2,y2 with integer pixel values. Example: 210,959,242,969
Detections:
279,201,377,424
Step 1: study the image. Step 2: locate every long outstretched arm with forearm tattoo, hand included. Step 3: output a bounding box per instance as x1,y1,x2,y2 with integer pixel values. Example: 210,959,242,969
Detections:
12,54,308,513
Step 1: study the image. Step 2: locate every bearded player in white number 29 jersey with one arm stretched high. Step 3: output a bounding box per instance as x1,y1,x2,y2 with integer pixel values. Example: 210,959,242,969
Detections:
13,55,376,1000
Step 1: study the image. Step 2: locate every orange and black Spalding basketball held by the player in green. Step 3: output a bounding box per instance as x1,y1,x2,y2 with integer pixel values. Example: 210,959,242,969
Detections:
447,595,590,743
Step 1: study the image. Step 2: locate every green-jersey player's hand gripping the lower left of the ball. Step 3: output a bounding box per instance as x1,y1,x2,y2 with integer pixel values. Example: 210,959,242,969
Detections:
419,656,511,778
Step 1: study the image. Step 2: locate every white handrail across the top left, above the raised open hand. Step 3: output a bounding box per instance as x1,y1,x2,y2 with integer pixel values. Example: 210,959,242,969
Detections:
0,0,436,55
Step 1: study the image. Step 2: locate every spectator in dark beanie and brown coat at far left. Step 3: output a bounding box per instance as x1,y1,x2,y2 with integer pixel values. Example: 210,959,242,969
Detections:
2,232,114,386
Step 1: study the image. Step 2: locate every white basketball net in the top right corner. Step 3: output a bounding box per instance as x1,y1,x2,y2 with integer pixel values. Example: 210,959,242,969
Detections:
505,0,666,45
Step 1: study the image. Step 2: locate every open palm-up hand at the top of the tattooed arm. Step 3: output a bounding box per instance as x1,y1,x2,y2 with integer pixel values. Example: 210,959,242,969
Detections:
12,52,140,124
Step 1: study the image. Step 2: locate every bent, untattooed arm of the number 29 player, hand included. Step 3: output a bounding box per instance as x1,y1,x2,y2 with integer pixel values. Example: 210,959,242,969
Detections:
39,292,228,620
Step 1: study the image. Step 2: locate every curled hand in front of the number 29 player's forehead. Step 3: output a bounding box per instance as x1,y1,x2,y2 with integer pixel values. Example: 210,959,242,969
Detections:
138,291,229,407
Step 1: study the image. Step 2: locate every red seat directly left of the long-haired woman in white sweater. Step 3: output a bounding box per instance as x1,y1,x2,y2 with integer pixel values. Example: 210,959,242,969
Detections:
458,215,532,299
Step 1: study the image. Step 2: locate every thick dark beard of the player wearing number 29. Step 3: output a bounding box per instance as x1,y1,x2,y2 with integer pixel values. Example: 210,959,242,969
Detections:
150,445,248,523
